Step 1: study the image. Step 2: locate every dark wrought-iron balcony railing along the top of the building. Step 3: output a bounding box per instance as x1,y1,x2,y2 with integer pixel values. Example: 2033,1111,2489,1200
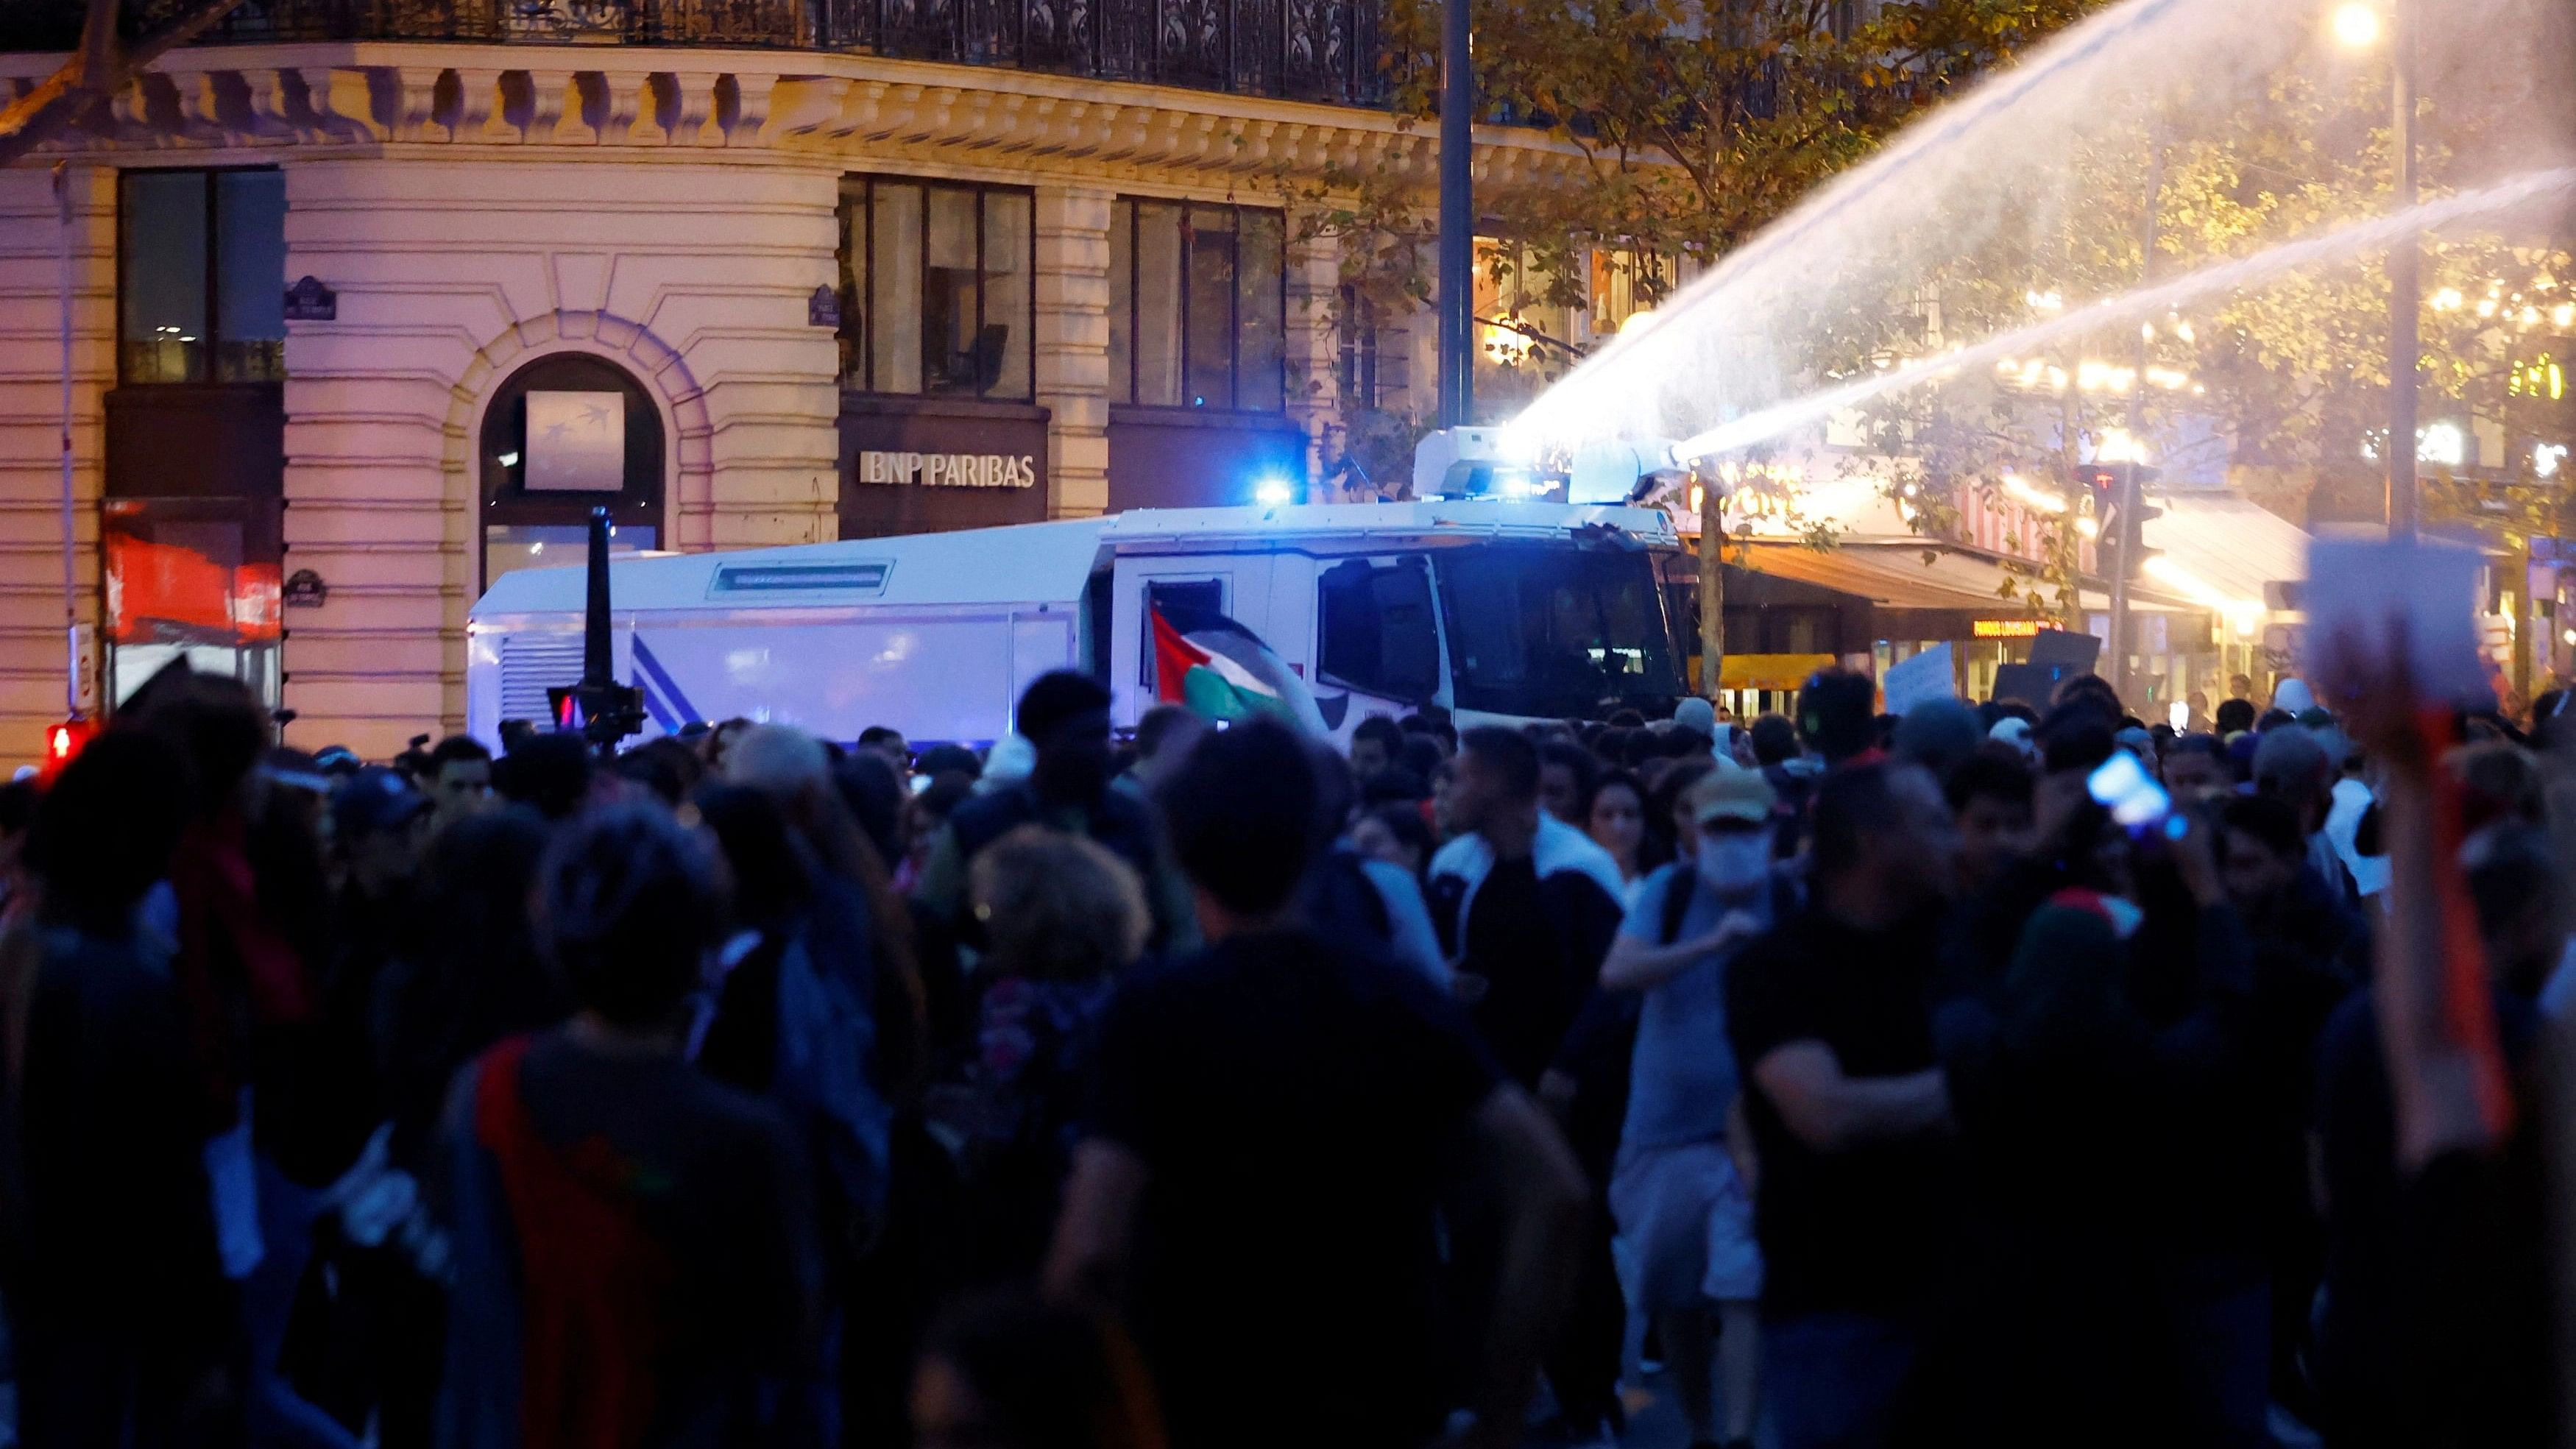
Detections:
0,0,1389,105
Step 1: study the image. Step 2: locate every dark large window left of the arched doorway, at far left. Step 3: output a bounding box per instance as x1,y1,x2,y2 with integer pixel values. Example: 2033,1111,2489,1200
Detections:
116,170,286,383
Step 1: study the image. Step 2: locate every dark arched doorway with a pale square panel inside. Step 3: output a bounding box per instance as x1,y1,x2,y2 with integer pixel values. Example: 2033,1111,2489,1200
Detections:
474,352,670,589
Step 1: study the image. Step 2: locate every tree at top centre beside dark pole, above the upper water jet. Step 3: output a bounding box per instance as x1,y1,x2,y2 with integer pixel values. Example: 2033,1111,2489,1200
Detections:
1293,0,2100,692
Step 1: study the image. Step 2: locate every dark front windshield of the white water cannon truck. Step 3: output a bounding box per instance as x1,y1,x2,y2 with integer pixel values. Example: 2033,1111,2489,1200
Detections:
1437,543,1682,718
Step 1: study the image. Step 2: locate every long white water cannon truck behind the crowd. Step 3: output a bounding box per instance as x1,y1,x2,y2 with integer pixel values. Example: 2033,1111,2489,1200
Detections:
467,502,1680,746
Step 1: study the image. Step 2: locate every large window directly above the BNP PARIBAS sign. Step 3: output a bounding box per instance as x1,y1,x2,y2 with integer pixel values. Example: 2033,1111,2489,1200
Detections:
840,175,1038,402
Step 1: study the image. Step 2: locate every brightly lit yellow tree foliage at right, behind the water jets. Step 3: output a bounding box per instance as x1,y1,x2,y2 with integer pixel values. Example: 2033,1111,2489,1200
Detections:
1824,74,2576,674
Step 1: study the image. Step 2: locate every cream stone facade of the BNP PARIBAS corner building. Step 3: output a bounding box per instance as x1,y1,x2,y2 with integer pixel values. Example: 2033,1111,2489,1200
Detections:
0,11,1574,757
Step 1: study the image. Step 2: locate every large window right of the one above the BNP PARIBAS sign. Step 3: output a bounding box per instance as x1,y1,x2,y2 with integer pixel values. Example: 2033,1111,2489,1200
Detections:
1111,201,1288,412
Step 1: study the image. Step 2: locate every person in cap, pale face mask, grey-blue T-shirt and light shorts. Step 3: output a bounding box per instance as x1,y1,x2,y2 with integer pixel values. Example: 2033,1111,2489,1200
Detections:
1602,767,1798,1444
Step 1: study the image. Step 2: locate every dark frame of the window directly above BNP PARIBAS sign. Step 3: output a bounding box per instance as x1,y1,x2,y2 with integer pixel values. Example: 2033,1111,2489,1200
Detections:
835,172,1038,402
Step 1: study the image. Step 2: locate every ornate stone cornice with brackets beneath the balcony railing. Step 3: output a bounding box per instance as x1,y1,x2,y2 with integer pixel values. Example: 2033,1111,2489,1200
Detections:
0,41,1587,191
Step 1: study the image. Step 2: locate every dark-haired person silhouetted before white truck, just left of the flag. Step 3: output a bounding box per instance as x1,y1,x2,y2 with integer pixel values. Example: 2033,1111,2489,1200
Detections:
917,669,1198,950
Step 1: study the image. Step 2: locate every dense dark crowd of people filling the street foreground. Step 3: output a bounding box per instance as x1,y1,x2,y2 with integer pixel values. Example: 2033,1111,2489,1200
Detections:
0,667,2576,1449
